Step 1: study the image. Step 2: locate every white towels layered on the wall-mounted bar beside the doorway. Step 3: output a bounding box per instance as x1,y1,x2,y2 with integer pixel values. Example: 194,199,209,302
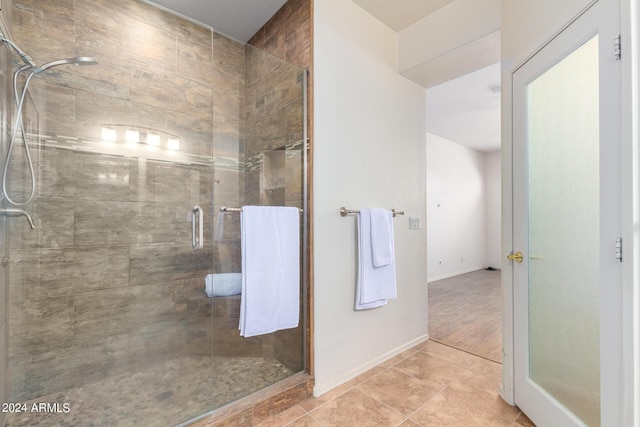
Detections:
356,209,397,310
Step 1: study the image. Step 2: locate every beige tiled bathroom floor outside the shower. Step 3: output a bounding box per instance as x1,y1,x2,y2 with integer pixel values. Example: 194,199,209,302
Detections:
252,341,533,427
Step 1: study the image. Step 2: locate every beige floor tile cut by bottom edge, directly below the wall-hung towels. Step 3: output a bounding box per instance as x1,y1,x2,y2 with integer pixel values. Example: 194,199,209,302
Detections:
310,389,405,427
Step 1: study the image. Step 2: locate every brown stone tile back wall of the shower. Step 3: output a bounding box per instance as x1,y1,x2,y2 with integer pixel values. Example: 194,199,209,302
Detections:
9,0,301,399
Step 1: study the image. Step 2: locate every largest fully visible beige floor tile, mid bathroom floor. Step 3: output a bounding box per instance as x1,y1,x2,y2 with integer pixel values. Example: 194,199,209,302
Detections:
357,368,442,415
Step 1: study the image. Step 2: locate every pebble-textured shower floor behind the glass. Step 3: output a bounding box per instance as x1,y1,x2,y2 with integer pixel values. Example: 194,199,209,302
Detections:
5,357,294,427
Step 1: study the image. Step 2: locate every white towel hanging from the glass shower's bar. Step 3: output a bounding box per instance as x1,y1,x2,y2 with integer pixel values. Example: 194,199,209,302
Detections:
238,206,300,337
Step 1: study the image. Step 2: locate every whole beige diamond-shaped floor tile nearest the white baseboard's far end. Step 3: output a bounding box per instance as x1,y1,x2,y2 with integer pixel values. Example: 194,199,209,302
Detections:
394,352,465,388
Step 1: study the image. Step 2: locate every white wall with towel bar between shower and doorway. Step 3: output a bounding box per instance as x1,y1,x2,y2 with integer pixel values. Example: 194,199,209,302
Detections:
313,0,427,395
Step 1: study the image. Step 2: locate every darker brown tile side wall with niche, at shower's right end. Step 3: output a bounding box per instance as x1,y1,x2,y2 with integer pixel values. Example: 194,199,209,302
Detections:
246,0,313,372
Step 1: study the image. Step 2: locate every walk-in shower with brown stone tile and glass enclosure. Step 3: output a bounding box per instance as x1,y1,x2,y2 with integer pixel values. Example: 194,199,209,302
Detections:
0,0,308,427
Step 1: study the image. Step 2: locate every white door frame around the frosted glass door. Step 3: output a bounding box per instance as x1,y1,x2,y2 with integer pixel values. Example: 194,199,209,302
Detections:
500,0,640,427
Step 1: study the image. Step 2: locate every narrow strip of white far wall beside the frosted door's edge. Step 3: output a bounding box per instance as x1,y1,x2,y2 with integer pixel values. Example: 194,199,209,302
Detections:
484,151,504,268
